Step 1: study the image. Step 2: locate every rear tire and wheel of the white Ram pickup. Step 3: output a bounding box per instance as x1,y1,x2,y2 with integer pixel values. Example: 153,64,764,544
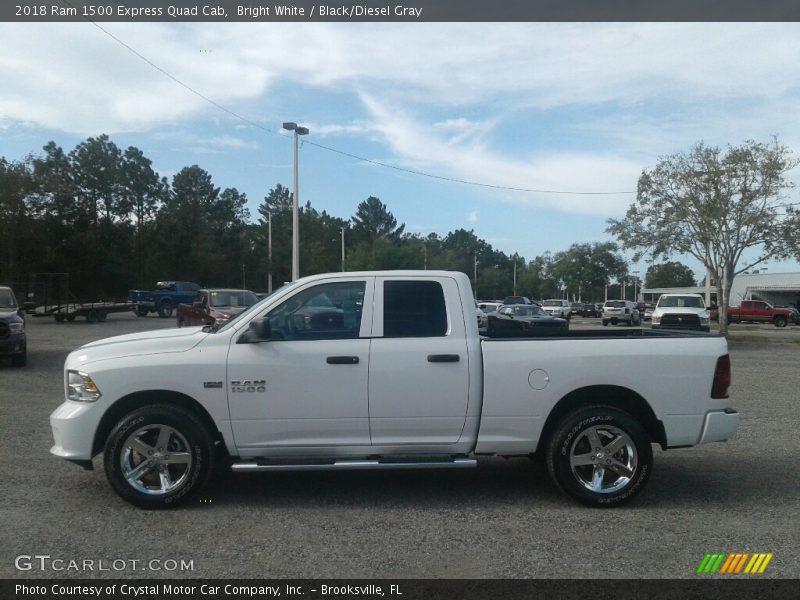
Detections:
545,404,653,508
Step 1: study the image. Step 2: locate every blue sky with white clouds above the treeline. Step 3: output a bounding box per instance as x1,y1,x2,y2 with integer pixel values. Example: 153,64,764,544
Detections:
0,23,800,275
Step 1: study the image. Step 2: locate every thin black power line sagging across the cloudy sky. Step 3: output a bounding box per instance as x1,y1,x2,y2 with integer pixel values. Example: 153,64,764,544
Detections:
61,8,636,196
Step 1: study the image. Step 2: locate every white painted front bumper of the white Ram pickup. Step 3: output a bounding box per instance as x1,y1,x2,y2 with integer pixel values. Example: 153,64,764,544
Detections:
50,400,103,461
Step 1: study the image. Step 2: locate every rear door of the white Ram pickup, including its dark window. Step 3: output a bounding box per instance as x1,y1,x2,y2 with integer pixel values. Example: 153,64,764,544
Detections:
369,277,472,446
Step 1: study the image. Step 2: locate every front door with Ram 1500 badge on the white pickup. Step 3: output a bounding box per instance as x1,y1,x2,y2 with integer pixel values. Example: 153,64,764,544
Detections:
225,277,374,456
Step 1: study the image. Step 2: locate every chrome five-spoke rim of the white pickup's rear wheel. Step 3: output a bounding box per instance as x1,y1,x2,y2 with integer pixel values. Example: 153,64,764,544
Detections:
569,425,638,494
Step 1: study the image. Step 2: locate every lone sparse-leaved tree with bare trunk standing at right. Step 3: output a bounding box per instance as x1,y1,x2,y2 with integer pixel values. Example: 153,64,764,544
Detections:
608,139,800,334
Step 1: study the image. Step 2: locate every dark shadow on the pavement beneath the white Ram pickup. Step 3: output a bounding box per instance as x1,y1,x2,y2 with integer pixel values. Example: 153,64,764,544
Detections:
190,455,800,510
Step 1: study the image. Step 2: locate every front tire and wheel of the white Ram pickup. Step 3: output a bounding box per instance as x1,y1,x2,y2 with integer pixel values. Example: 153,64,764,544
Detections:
103,404,216,509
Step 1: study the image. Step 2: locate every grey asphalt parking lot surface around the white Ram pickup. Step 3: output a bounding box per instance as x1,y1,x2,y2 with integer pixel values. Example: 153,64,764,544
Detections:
0,314,800,578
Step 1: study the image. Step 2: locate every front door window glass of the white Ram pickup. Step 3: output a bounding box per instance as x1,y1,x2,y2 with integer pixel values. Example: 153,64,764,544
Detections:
267,281,366,341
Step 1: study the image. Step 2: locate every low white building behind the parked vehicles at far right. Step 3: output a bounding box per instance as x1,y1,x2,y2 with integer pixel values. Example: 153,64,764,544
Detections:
642,272,800,306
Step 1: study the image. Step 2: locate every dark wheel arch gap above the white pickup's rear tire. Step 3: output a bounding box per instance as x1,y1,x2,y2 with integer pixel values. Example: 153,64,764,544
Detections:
536,385,667,455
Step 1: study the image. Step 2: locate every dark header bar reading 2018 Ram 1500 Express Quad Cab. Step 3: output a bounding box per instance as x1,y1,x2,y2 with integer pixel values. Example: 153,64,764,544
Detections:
0,0,800,23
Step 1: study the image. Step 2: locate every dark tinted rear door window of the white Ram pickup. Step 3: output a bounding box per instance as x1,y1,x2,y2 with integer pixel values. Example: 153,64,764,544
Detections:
383,281,447,338
